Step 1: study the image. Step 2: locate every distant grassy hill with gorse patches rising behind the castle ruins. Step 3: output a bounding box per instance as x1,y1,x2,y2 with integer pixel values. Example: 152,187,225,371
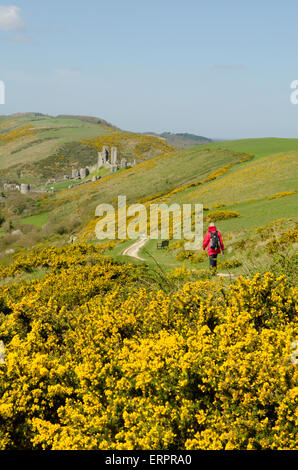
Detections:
0,113,172,186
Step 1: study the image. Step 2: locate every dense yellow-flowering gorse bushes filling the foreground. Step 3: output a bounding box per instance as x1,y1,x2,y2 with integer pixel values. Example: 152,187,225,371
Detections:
0,244,298,450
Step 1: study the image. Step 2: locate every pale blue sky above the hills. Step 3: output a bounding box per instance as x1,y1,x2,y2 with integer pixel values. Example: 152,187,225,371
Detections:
0,0,298,139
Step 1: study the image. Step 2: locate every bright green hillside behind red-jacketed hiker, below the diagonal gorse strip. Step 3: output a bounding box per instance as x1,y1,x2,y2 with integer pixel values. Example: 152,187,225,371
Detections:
106,142,298,274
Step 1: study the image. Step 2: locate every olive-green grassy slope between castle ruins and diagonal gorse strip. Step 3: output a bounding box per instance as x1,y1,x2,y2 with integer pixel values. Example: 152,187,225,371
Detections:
49,149,249,236
